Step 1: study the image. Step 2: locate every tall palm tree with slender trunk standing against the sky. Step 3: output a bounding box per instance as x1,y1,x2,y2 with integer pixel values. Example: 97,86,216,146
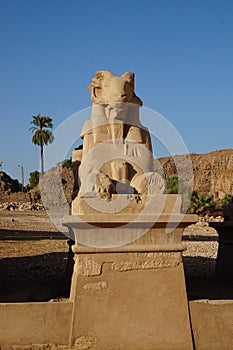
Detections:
29,113,54,174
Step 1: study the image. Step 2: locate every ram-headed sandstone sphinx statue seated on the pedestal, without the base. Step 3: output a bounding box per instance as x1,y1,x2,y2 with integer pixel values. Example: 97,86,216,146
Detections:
73,71,164,214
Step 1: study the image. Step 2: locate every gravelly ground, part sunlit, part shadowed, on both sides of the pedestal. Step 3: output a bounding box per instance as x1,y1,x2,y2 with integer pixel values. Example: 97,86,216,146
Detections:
0,211,233,302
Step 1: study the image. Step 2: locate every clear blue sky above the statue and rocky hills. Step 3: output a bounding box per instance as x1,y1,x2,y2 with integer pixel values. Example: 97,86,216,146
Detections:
0,0,233,183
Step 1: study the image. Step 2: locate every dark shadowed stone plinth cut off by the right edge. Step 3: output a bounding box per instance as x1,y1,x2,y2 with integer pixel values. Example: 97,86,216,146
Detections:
209,221,233,278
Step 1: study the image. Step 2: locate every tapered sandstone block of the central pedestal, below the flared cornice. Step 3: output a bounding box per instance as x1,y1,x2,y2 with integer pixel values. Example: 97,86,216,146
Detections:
70,252,193,350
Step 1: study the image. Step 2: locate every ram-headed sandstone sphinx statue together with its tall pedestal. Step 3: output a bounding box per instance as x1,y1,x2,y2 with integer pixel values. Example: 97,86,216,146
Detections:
62,71,197,350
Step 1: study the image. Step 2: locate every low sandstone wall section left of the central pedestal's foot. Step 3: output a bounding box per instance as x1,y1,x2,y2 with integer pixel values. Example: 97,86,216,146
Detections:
0,301,73,350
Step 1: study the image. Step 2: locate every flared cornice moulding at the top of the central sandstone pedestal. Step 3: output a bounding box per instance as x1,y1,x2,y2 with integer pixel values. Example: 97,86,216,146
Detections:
64,213,197,252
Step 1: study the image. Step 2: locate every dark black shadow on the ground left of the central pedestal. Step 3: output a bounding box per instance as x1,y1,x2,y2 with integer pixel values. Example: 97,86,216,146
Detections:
0,253,73,302
